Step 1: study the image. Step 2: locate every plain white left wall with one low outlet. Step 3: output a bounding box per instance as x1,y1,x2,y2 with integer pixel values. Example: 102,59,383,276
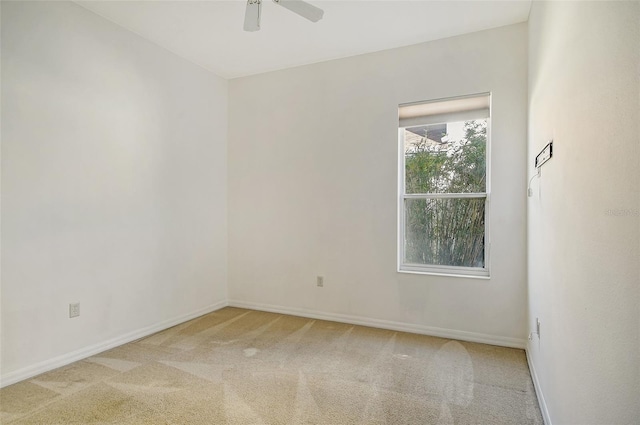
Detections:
1,2,227,384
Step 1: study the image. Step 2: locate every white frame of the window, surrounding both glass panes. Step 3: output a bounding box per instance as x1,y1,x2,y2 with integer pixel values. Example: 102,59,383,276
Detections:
398,93,491,279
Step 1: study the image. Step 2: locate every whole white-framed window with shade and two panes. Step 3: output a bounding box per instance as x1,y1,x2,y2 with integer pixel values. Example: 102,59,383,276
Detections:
398,94,491,277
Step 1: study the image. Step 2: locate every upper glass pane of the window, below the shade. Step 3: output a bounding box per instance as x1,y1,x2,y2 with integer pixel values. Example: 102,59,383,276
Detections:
404,119,487,193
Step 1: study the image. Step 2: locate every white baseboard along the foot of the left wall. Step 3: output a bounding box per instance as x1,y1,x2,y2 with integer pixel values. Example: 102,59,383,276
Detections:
0,301,227,388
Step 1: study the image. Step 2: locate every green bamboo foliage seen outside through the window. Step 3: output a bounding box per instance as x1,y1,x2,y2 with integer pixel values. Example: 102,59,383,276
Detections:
404,120,487,267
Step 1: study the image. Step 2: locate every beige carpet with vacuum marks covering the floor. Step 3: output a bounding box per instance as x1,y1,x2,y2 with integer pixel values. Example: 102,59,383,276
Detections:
0,307,542,425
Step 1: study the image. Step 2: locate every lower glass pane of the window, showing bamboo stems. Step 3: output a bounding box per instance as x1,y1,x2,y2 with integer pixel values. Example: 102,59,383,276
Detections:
404,198,485,267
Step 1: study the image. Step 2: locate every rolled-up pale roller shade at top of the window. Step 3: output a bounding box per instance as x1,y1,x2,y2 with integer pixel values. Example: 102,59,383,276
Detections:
398,93,491,127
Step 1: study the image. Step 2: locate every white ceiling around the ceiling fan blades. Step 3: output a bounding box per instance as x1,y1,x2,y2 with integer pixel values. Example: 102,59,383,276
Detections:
77,0,531,78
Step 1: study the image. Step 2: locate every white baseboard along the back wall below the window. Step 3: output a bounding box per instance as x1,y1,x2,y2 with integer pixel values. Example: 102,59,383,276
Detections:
229,300,526,349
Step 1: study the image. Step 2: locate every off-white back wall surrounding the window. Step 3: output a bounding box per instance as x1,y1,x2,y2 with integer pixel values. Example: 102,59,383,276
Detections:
228,24,527,345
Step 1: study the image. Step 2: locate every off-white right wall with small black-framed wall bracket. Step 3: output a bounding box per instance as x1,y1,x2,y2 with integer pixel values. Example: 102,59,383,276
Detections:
527,1,640,425
